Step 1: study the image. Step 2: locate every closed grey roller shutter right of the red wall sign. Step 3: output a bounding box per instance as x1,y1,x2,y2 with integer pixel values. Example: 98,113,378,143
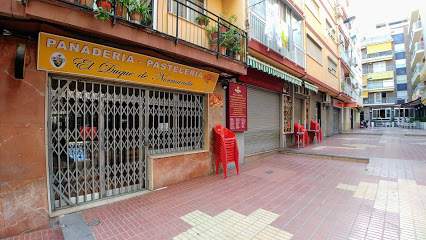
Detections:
244,86,280,155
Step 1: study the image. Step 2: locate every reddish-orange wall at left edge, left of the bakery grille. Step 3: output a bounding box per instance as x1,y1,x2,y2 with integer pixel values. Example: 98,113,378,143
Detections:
0,36,49,238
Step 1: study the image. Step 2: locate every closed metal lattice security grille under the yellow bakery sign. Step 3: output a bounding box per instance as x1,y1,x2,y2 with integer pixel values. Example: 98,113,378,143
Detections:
48,78,204,210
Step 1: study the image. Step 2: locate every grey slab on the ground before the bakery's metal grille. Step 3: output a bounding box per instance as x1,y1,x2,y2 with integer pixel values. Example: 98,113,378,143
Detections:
59,212,95,240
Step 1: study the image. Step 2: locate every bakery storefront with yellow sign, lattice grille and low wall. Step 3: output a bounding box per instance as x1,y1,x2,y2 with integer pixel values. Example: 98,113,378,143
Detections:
37,33,218,211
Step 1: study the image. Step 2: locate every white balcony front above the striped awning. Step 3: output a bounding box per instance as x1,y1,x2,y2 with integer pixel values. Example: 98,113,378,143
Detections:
250,12,306,68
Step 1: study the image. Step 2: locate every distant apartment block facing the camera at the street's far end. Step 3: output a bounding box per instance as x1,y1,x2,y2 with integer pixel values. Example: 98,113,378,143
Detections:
362,18,414,126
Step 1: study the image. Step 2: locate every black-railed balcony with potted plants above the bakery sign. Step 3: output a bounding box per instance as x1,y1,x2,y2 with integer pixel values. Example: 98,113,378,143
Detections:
57,0,248,63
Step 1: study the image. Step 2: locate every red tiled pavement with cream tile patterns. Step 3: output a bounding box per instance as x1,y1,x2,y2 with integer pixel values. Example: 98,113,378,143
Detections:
4,128,426,240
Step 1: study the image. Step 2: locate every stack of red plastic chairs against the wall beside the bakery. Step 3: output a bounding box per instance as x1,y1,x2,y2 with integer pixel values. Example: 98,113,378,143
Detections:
214,125,240,178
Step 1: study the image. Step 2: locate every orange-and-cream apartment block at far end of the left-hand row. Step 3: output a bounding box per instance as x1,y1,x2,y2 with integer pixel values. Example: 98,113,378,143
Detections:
305,0,362,136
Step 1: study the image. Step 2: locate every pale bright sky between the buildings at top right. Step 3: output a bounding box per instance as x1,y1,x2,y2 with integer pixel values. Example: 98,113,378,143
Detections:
348,0,426,35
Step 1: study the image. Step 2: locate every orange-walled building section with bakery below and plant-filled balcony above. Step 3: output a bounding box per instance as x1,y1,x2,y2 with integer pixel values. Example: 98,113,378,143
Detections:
0,0,248,238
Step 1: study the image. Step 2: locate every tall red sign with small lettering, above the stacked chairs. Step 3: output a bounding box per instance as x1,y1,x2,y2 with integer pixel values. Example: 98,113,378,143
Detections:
226,83,247,131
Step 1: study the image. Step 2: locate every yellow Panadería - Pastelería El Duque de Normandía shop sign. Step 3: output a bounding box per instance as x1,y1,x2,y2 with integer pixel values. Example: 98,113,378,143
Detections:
37,32,219,93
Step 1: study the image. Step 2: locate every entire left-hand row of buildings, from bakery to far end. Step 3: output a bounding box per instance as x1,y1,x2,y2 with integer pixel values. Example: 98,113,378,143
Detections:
0,0,362,238
